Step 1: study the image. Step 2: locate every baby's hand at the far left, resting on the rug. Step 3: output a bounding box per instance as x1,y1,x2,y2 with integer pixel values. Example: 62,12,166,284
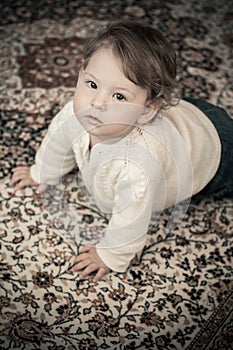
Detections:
10,166,47,193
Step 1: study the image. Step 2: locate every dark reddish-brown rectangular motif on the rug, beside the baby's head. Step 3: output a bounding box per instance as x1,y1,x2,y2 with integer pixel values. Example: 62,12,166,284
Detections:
17,38,86,88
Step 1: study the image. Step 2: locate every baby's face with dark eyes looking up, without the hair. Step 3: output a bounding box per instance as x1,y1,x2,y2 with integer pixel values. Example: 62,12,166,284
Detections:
74,48,153,142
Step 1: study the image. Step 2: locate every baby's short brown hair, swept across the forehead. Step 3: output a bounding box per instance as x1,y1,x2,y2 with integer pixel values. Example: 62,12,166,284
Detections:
83,20,177,108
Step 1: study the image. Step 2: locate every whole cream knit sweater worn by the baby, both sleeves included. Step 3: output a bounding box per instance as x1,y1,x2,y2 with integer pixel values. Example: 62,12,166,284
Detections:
31,100,221,272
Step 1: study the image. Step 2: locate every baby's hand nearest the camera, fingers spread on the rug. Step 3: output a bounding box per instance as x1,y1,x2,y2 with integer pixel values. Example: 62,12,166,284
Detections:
72,246,110,282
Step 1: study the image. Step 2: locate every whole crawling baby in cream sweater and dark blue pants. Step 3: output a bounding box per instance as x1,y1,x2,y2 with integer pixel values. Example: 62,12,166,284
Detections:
11,21,233,281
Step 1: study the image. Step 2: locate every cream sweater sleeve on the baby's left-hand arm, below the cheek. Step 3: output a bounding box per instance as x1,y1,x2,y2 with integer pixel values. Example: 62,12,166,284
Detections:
30,101,80,185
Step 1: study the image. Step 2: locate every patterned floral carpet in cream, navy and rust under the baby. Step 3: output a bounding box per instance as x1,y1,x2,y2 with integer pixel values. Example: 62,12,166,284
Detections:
0,0,233,350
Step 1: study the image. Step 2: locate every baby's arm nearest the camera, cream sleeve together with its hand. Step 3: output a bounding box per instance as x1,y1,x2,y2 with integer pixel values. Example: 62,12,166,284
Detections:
72,162,157,282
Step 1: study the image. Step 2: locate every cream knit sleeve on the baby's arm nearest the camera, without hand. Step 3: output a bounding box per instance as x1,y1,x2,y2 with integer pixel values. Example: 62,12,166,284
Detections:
96,159,165,272
